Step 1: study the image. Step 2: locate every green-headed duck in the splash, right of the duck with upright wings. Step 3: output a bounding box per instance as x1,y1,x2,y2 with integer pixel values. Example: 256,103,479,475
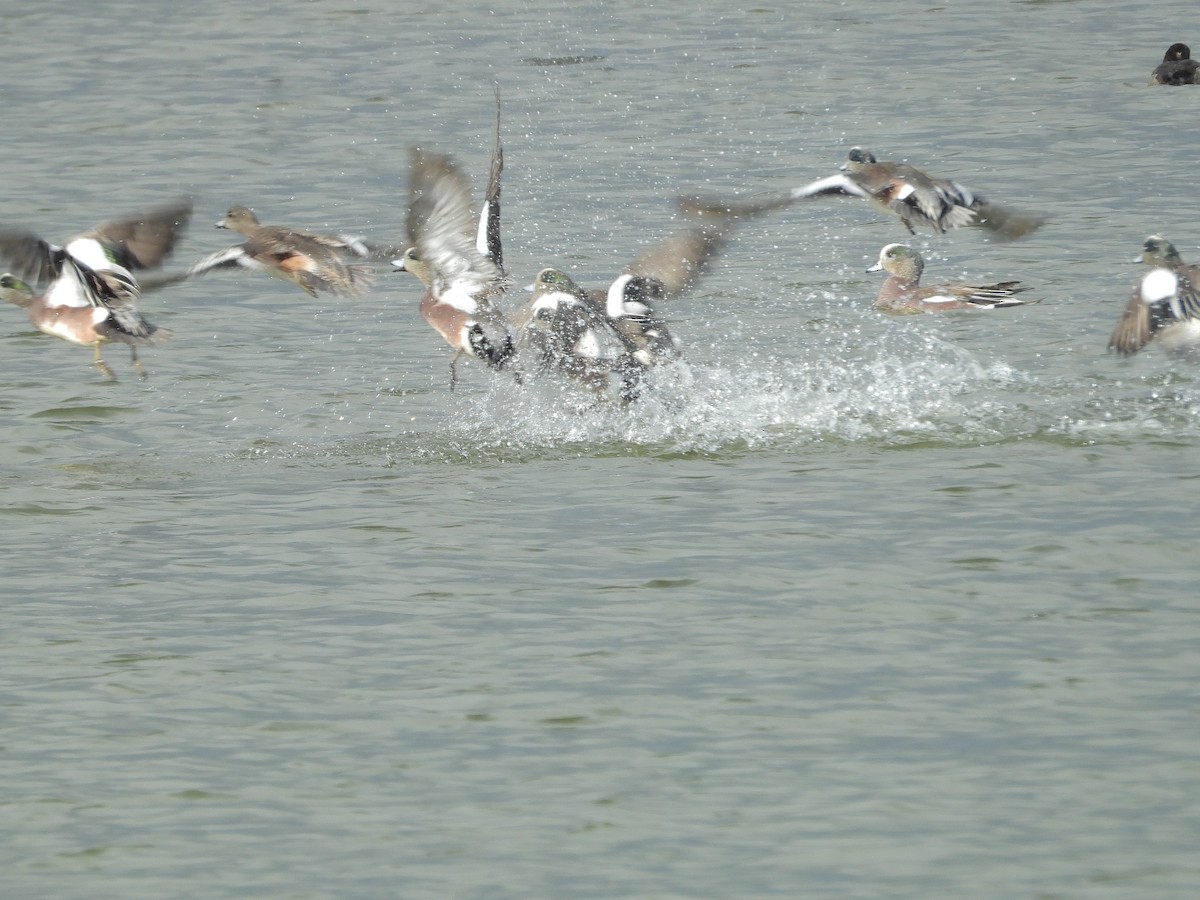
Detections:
512,268,646,402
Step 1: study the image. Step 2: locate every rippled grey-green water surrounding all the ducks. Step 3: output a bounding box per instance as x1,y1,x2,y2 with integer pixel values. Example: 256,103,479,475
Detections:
0,0,1200,898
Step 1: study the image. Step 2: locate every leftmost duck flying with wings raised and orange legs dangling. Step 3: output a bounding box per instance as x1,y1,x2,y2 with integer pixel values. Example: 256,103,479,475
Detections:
0,199,192,380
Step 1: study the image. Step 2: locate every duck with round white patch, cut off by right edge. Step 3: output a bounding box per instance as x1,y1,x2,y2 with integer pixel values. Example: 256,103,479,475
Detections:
1109,235,1200,356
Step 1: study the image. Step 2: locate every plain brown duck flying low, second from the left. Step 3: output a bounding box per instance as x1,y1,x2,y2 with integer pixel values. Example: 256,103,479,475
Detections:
185,206,374,296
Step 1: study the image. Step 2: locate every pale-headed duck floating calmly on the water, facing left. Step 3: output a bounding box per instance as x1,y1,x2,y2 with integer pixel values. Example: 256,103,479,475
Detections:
866,244,1040,314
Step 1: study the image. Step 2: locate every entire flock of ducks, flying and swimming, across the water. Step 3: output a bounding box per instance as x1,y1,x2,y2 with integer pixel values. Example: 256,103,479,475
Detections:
0,43,1200,393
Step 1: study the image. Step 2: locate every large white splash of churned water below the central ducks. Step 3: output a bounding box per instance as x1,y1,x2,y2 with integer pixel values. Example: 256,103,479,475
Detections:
420,331,1021,456
